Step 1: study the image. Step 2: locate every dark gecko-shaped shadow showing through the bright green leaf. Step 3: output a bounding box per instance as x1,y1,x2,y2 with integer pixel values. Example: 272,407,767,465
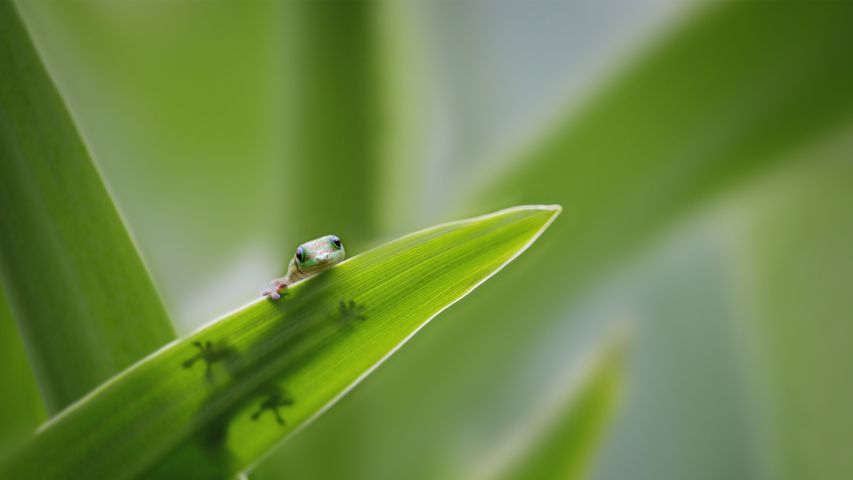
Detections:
154,278,367,472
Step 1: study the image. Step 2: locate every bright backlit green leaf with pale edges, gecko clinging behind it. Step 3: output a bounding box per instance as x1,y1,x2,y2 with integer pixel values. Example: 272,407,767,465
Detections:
0,206,559,479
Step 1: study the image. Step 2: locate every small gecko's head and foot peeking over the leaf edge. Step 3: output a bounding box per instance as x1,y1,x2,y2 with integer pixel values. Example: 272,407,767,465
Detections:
263,235,346,300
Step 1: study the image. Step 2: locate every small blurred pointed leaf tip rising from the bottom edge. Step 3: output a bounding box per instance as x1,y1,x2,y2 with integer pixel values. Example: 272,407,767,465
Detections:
490,339,625,480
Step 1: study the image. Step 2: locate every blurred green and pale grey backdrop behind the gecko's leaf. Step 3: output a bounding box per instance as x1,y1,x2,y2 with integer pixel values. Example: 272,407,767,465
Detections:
0,0,853,479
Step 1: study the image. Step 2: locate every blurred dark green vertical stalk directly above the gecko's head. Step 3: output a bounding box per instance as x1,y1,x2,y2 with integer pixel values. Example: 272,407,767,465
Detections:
282,2,380,257
